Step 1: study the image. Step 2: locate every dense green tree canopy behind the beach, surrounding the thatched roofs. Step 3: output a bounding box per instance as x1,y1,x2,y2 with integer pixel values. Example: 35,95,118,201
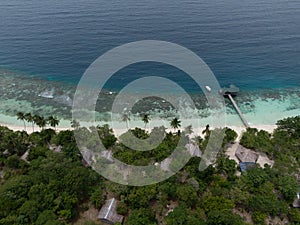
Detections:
0,116,300,225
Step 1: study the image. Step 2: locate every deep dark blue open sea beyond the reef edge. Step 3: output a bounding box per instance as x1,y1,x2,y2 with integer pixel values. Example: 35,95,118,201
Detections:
0,0,300,90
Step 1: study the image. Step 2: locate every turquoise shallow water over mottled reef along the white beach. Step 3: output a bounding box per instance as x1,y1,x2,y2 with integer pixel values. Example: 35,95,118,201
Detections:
0,70,300,126
